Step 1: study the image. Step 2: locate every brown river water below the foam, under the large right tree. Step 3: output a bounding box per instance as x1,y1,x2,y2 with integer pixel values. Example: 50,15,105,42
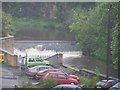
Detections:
64,57,118,78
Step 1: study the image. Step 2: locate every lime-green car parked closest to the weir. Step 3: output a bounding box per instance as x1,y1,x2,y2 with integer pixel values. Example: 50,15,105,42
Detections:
23,56,50,67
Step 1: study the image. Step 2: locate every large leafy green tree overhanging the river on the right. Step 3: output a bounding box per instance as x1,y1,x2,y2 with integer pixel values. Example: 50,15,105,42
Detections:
69,3,117,67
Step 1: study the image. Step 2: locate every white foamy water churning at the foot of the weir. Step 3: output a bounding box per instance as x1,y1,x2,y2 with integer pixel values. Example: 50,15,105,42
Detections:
14,48,82,58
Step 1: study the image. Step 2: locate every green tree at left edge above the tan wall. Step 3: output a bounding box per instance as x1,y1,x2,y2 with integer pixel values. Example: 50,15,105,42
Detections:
2,12,15,36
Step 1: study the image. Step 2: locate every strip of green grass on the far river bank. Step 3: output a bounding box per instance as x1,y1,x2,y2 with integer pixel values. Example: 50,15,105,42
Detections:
13,18,65,31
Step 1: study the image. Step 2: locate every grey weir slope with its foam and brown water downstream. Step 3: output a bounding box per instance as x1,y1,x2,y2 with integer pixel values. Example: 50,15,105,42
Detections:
14,40,118,78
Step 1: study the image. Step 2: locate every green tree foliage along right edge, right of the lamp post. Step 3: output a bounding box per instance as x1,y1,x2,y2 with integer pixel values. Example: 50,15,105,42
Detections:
112,2,120,68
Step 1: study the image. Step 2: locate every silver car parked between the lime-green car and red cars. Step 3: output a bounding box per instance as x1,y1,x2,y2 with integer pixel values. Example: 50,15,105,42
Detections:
25,65,55,76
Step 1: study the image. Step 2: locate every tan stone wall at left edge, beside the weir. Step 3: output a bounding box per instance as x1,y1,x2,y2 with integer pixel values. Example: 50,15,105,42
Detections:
0,36,17,66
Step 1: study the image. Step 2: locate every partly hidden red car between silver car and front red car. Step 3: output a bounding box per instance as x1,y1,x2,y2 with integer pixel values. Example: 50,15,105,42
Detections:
35,68,63,79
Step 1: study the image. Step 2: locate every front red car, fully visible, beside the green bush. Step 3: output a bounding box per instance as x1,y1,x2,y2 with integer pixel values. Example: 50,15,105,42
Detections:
45,72,79,85
